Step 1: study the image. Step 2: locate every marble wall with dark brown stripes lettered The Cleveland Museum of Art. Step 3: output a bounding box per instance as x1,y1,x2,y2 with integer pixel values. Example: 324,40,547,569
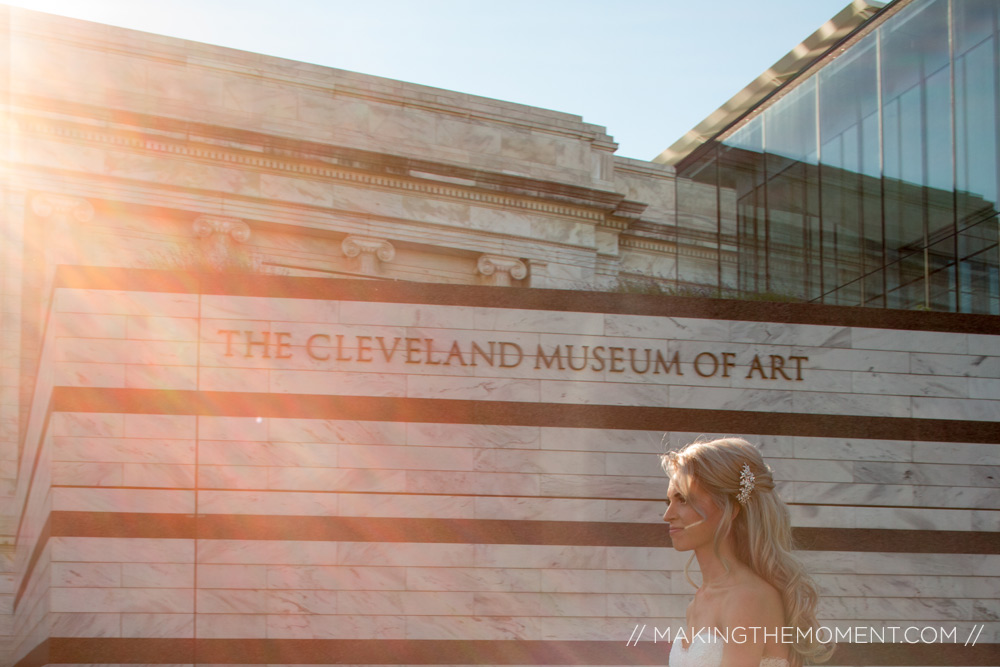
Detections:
16,267,1000,665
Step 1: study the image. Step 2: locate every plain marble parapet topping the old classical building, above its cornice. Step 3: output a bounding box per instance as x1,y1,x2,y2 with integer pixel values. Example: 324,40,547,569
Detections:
0,8,616,190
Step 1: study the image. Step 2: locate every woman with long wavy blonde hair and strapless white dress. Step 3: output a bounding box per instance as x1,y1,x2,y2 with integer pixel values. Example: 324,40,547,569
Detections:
662,438,833,667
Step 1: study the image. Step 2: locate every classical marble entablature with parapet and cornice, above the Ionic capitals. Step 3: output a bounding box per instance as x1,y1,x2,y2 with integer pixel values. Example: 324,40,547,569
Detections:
0,9,696,298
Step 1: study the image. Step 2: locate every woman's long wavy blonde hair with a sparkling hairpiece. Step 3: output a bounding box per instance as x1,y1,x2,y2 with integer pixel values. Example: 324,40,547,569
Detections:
661,438,834,666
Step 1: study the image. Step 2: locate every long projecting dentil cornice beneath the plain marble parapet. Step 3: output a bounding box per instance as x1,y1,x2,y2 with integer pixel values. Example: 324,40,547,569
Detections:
9,110,632,224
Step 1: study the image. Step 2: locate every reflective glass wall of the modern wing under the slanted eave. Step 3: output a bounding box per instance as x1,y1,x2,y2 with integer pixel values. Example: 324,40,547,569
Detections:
677,0,1000,314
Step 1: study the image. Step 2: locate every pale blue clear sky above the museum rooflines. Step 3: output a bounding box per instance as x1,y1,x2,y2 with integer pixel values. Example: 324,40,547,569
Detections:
0,0,850,160
